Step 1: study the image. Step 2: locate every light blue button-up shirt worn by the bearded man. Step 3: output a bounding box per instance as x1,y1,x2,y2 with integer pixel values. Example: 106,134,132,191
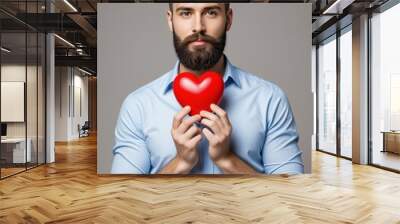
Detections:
111,57,304,174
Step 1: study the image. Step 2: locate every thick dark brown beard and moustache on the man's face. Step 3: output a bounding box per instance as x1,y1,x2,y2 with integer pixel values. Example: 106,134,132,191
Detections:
173,26,226,71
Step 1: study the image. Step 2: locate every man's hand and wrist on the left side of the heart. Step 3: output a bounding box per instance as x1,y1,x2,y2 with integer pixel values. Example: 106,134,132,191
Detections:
161,106,201,174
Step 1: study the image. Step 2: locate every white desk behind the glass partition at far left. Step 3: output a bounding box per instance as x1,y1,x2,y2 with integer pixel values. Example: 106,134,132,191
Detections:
1,138,32,163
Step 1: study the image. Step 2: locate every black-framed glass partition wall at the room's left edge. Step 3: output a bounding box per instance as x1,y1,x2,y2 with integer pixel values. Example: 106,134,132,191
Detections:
0,1,46,179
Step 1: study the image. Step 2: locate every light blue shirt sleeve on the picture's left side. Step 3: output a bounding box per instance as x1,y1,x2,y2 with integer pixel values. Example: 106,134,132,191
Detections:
111,97,150,174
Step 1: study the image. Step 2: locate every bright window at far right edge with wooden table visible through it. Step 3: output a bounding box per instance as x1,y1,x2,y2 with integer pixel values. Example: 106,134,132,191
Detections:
370,1,400,170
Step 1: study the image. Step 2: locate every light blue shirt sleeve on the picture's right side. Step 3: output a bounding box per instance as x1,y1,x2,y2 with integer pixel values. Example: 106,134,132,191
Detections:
262,88,304,174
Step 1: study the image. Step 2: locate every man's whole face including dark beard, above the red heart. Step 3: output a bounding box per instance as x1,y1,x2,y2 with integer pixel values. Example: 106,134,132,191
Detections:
168,3,232,71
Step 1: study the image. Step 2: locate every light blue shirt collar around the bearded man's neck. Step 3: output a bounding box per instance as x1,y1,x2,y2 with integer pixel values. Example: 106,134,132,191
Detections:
163,55,240,94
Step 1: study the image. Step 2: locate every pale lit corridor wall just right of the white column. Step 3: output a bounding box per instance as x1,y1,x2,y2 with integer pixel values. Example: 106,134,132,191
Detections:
55,67,88,141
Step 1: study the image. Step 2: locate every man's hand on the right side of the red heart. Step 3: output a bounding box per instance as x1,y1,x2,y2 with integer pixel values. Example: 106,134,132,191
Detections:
200,104,232,163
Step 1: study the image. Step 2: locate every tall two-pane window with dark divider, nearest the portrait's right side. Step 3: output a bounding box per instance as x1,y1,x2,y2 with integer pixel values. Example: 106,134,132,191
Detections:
317,24,353,159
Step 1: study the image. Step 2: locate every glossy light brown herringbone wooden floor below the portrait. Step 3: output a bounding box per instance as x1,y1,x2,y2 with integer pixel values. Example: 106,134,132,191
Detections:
0,134,400,224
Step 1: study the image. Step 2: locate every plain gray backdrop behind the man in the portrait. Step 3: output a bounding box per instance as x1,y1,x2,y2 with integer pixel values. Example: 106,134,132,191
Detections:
97,3,313,174
